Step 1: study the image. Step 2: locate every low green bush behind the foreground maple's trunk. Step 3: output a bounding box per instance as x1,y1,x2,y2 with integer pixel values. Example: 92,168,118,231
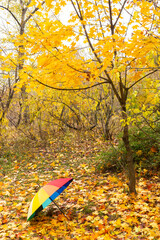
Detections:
97,127,160,172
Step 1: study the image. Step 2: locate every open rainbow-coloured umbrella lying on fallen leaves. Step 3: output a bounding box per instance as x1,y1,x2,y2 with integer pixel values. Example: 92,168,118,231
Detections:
27,178,73,221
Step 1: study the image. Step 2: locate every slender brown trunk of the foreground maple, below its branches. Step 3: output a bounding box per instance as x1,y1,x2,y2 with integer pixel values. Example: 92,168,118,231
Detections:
122,112,136,194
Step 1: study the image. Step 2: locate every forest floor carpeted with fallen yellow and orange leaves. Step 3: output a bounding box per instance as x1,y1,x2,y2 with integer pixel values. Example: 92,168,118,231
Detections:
0,134,160,240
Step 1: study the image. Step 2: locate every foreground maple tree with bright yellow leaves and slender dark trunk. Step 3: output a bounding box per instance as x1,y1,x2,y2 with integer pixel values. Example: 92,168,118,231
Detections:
9,0,159,192
